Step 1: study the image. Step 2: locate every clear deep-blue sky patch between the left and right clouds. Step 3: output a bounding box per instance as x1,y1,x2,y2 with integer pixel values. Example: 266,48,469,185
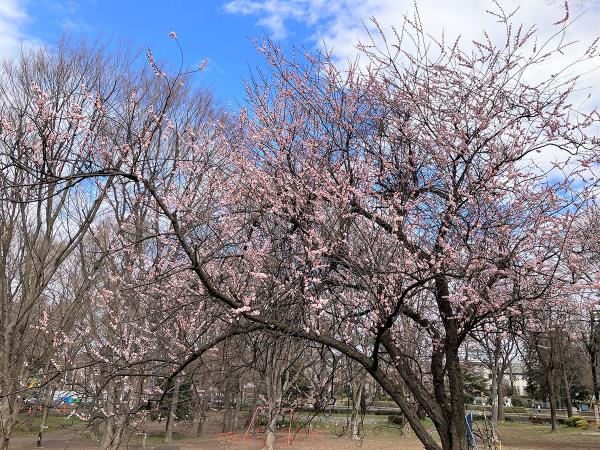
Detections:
9,0,312,101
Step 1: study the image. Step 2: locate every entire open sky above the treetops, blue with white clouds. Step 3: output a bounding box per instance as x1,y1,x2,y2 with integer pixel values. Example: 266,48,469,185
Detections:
0,0,600,110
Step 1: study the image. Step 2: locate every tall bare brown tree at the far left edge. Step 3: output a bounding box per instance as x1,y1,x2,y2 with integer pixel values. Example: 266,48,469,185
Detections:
0,41,128,449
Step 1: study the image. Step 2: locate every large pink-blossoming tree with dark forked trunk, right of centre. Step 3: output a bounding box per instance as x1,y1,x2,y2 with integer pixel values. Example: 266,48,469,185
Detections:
119,7,598,449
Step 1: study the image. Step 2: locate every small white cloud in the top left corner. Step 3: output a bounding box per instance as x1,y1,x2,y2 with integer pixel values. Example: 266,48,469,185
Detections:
0,0,39,58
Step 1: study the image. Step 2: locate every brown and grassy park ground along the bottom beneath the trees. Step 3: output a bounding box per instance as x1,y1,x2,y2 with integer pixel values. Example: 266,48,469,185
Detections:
10,412,600,450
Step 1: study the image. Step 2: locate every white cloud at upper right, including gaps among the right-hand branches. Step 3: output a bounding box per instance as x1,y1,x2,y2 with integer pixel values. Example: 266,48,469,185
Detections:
225,0,600,173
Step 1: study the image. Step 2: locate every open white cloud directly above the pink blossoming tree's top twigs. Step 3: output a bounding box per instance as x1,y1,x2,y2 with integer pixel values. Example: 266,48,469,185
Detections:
224,0,600,58
